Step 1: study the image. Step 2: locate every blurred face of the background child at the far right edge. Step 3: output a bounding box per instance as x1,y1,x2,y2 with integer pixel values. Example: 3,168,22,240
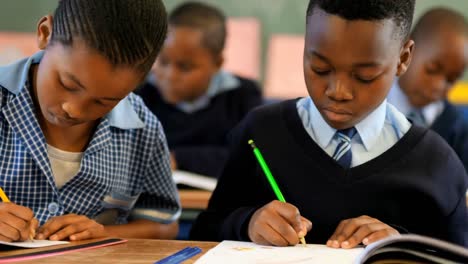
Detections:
399,30,468,107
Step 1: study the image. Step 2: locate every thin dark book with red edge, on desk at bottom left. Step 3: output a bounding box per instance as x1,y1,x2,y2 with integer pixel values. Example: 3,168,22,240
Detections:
0,238,127,264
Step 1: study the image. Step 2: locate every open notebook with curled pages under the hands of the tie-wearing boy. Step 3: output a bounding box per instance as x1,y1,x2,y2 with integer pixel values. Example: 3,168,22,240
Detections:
195,235,468,264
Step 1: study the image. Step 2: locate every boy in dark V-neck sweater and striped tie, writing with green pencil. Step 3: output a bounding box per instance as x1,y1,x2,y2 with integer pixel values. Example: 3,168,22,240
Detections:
191,0,468,248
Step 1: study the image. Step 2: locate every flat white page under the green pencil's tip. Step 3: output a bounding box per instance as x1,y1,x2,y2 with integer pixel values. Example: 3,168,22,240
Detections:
195,241,364,264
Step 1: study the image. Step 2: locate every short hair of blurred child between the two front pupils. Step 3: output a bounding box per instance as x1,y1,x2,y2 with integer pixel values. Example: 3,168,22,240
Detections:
169,2,226,55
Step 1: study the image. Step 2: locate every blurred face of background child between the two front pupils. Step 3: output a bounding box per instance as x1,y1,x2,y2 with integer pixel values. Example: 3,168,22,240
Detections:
152,26,222,103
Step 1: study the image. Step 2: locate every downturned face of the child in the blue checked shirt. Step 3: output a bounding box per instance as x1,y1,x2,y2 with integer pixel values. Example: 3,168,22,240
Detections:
34,16,142,127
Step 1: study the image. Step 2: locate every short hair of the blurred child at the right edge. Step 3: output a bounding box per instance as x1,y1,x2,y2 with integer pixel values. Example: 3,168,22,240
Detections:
411,7,468,40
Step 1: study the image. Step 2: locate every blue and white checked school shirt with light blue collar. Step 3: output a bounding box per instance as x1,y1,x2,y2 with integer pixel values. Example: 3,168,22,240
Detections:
0,52,180,224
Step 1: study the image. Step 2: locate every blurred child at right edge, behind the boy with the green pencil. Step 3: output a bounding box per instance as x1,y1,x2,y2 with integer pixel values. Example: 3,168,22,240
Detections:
388,8,468,171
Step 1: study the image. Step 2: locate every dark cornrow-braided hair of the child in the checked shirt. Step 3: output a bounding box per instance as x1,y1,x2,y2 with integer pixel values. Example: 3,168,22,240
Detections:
51,0,167,75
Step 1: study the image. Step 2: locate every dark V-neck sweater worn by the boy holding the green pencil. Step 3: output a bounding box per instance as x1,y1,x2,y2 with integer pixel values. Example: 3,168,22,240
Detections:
191,100,468,245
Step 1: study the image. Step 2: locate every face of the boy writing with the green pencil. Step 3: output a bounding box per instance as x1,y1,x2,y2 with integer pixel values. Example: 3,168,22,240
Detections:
304,8,413,129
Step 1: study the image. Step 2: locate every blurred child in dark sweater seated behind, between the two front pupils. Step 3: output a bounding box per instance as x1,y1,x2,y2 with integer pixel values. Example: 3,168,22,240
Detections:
136,2,261,177
